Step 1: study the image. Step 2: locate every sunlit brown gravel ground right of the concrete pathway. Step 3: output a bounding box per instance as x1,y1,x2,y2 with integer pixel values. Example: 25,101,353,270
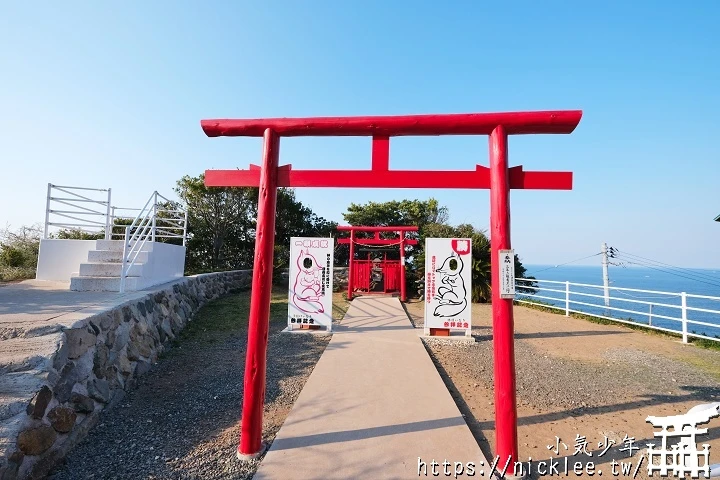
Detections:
407,303,720,479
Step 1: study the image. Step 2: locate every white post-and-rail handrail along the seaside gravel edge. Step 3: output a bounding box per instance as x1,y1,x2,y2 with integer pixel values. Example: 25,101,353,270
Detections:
515,278,720,343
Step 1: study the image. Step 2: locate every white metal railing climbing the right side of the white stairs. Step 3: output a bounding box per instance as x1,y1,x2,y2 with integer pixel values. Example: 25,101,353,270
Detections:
120,191,187,293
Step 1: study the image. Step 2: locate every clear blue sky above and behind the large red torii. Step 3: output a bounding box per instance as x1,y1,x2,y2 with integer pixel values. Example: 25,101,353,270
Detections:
0,0,720,268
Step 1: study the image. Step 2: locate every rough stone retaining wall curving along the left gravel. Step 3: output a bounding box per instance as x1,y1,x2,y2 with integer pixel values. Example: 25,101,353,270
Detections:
0,270,252,480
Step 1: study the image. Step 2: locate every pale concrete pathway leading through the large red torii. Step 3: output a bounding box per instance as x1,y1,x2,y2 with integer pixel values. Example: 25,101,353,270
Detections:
253,297,489,480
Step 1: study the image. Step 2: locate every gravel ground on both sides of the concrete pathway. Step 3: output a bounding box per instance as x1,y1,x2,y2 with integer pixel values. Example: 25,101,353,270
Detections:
46,296,720,480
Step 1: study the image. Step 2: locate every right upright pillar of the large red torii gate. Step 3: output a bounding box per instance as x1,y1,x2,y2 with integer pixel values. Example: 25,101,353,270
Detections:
490,126,518,465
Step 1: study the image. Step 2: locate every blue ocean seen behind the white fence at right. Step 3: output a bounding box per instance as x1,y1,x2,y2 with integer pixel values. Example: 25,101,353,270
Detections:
517,262,720,338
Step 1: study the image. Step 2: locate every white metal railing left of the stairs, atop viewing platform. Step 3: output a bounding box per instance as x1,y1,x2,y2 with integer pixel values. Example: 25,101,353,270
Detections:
44,183,112,240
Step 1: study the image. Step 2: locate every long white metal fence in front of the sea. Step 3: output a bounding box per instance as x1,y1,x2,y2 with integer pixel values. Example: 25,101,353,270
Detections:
516,278,720,343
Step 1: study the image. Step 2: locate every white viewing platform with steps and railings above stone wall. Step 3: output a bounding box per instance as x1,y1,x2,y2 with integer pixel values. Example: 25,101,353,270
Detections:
35,184,187,292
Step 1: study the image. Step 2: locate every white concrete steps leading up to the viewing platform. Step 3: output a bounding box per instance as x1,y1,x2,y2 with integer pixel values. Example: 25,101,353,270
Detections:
70,240,153,292
